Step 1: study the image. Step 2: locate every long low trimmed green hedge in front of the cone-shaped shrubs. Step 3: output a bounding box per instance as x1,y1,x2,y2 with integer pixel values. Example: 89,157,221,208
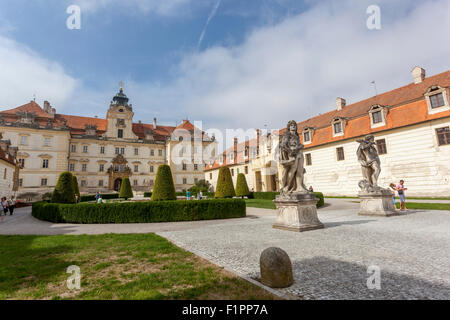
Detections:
32,199,246,224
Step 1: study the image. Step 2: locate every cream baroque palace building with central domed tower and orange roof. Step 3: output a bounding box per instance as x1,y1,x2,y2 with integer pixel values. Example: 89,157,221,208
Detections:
0,88,217,201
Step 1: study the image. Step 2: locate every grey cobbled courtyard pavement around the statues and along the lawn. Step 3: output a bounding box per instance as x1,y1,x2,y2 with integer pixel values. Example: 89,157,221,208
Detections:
0,199,450,299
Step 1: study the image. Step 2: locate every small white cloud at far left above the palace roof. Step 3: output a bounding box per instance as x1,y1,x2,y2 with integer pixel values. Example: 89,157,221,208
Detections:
0,36,78,111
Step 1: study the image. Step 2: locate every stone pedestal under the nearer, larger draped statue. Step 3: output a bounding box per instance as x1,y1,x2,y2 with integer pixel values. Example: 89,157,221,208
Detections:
273,192,324,232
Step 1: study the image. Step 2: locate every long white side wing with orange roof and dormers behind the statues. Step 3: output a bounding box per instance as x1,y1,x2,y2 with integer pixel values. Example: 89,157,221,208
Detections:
205,67,450,197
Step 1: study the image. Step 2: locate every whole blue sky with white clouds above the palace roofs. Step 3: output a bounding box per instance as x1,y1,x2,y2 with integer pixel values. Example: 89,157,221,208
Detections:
0,0,450,134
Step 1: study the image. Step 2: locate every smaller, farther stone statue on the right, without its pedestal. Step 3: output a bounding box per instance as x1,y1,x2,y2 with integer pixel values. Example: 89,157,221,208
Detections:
356,134,381,192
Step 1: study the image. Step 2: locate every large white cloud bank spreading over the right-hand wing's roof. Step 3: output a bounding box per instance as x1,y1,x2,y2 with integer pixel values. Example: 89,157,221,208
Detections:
132,0,450,128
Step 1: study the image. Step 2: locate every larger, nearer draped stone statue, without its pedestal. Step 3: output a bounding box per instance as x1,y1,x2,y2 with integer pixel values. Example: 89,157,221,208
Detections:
280,120,308,195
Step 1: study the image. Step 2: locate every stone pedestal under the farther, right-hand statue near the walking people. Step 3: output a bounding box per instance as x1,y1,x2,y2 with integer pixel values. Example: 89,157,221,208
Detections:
358,188,398,217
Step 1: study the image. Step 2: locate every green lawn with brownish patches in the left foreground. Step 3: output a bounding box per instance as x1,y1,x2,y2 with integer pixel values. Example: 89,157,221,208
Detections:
0,234,275,300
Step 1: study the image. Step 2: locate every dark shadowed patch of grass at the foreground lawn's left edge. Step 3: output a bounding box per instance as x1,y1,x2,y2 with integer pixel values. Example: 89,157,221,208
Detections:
0,236,74,300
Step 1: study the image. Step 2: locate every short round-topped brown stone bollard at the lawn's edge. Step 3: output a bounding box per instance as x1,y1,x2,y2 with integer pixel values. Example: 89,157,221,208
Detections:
259,247,294,288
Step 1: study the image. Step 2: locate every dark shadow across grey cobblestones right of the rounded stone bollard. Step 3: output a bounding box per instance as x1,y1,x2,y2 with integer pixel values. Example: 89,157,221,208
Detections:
291,256,450,300
